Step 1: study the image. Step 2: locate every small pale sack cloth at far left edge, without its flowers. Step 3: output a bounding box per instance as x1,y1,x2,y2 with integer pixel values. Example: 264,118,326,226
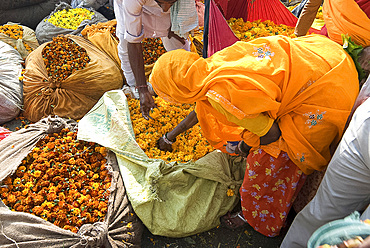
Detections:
0,22,39,59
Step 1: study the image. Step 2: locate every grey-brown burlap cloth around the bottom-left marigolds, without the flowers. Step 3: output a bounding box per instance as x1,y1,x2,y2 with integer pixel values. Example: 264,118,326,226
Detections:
0,117,143,248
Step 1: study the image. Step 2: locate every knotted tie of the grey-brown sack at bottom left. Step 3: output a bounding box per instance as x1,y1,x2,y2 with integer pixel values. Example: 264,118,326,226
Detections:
77,222,108,247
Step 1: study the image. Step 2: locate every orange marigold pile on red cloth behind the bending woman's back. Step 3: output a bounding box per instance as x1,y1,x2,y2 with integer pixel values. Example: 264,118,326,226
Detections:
227,18,296,41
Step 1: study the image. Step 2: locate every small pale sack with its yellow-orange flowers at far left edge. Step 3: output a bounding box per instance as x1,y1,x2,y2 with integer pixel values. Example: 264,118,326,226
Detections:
0,22,39,59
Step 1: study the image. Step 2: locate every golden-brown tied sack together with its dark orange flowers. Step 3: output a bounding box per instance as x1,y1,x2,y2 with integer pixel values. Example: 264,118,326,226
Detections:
23,35,123,122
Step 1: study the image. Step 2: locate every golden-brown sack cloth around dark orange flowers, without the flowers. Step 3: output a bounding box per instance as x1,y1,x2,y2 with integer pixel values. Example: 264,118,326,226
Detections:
23,35,123,122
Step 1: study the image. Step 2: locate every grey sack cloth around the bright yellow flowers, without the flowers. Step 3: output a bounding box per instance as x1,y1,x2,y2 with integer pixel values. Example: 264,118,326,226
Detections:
35,2,108,44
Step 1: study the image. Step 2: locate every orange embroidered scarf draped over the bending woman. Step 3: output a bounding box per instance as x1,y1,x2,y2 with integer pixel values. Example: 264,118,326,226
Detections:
150,35,359,174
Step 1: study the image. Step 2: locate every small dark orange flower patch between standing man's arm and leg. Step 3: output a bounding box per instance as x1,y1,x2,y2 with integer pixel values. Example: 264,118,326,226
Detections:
142,38,166,65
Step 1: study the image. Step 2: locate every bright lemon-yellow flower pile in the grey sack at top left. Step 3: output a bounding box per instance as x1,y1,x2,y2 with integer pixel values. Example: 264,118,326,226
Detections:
46,8,94,30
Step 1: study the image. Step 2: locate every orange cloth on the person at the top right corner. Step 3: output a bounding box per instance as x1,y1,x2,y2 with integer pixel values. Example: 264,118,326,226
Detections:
323,0,370,47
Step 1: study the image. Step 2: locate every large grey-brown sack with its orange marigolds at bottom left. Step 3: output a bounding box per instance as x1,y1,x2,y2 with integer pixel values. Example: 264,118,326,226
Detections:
0,116,143,248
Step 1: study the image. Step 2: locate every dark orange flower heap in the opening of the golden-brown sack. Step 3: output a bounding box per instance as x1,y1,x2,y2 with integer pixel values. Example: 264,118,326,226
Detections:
42,36,90,81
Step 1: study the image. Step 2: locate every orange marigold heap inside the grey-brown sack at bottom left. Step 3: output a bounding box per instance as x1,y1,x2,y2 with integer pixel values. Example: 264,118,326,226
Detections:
0,128,111,233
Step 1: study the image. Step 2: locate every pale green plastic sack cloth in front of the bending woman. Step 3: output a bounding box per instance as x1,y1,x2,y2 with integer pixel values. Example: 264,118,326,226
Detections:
77,90,245,237
